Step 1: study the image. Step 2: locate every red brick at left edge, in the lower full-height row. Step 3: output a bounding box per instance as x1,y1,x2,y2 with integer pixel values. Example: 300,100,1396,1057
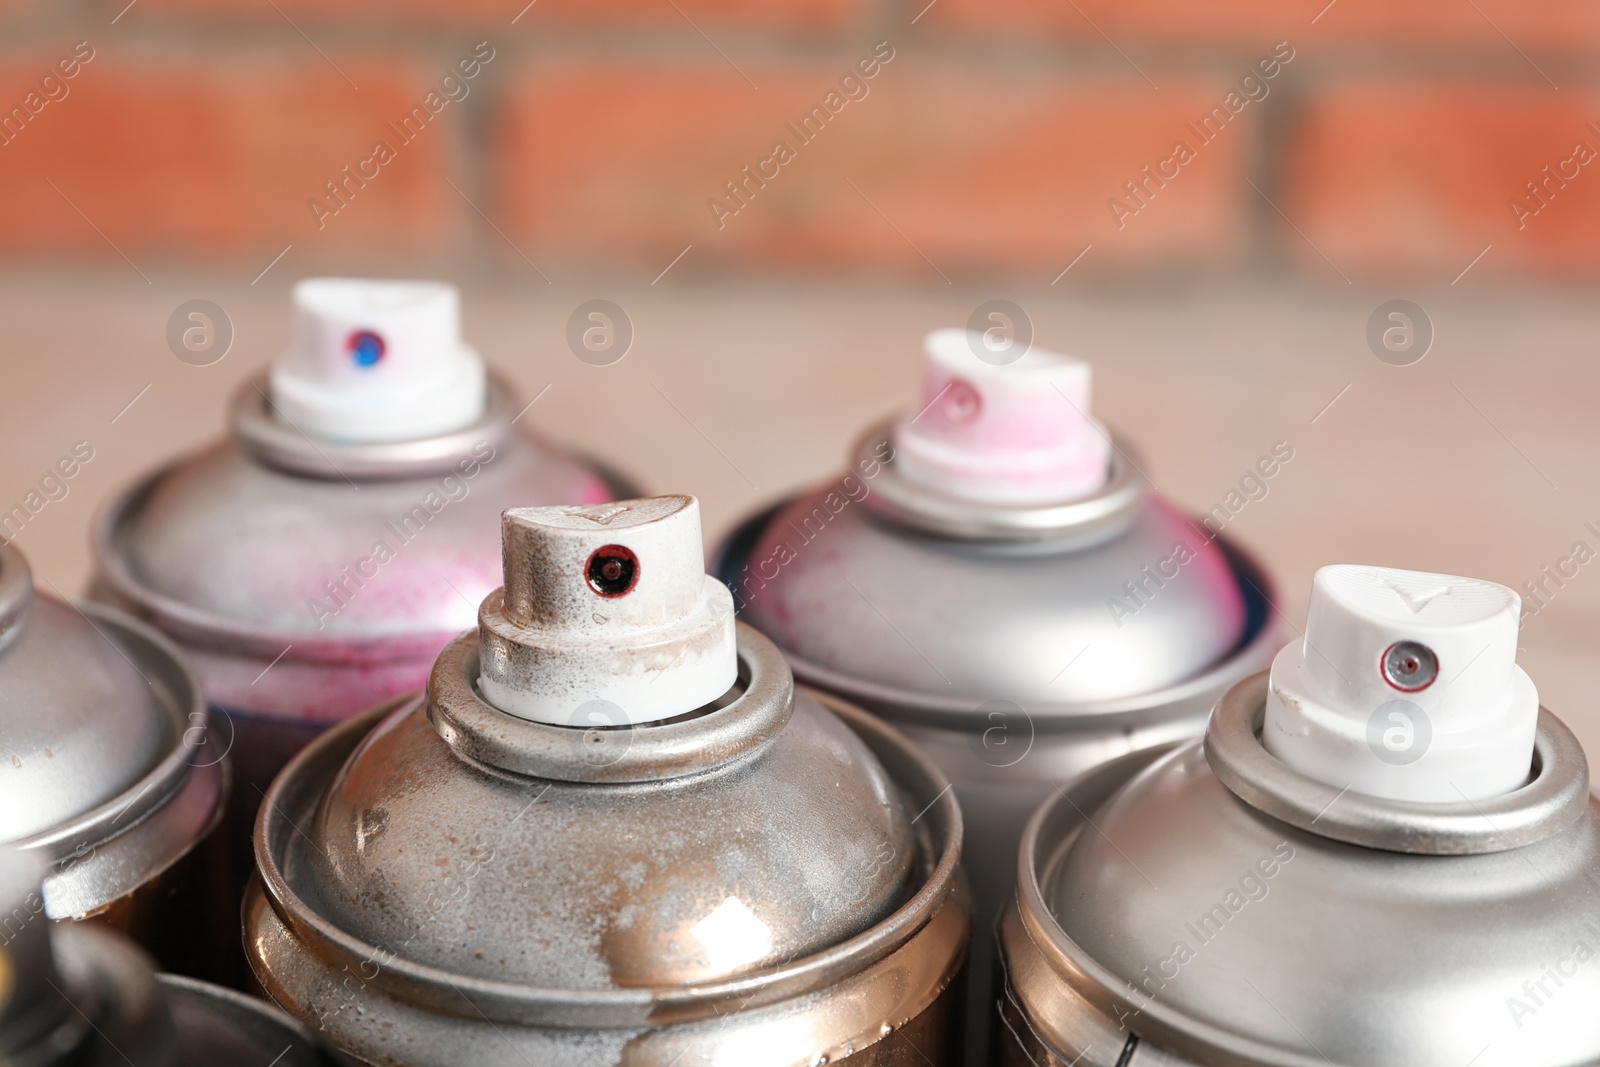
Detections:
0,54,461,258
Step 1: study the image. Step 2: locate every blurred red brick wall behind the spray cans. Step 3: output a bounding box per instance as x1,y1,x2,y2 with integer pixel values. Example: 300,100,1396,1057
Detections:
0,0,1600,282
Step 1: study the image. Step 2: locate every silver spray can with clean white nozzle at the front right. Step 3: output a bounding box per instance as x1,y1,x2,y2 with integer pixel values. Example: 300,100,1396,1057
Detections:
998,566,1600,1067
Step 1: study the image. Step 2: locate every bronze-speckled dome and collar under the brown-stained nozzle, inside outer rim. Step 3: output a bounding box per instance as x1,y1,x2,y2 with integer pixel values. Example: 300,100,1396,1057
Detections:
269,617,915,992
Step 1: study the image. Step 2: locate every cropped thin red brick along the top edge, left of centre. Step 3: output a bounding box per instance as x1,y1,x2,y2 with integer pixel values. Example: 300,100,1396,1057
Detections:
131,0,869,31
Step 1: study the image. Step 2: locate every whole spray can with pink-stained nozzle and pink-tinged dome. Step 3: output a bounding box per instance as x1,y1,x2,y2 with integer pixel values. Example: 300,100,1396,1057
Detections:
714,330,1277,1062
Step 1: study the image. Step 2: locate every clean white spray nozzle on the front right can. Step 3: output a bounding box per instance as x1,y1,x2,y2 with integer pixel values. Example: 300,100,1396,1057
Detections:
1261,565,1539,803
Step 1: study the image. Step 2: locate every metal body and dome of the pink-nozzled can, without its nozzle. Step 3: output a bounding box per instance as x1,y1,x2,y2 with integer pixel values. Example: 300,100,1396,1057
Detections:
717,427,1280,1064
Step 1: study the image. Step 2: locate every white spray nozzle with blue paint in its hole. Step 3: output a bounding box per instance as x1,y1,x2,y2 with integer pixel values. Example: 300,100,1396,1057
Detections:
272,278,488,443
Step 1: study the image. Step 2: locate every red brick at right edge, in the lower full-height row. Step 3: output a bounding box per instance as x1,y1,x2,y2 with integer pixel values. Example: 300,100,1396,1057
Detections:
1285,85,1600,280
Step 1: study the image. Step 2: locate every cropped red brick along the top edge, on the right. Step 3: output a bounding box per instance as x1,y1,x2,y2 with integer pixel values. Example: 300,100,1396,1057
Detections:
917,0,1600,51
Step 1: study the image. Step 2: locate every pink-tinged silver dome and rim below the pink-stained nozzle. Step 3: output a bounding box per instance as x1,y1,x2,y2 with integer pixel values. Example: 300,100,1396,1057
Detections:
717,424,1277,723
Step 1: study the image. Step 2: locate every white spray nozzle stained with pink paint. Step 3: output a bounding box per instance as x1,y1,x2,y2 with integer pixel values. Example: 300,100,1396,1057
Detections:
894,330,1110,507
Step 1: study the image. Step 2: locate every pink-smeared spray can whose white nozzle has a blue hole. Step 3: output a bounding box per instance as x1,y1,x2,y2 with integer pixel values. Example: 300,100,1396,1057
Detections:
84,278,619,927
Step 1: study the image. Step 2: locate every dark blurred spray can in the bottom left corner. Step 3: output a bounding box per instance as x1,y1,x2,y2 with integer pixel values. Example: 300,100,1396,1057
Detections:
0,848,344,1067
